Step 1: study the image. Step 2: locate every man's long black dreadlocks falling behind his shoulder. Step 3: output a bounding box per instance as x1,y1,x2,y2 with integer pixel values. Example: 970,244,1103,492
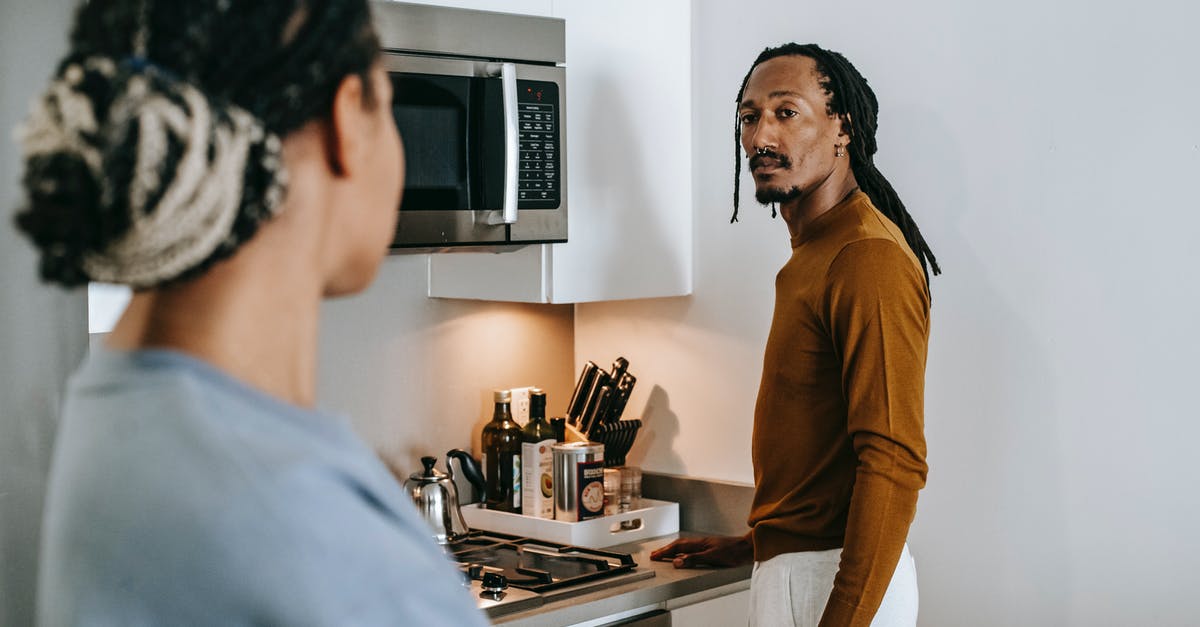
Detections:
730,43,942,282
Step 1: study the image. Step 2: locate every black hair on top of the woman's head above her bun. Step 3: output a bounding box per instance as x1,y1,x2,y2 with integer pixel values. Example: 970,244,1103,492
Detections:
64,0,379,136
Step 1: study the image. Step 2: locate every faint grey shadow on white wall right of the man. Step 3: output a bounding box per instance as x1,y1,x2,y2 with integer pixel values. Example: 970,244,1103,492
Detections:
881,105,1072,626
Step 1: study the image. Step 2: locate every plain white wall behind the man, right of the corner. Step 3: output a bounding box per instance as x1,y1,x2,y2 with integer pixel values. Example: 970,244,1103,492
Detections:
576,0,1200,626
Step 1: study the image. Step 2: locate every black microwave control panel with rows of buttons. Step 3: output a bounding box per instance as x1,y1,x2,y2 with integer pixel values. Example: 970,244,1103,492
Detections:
517,80,563,209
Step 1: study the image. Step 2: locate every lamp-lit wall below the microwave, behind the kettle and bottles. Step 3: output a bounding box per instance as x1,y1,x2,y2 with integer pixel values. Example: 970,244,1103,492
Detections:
318,253,575,476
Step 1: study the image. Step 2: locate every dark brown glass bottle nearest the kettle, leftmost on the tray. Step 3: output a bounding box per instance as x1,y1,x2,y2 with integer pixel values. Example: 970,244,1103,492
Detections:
481,389,522,514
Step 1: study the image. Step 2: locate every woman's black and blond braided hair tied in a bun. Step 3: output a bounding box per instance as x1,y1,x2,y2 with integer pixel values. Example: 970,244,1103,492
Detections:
16,0,379,289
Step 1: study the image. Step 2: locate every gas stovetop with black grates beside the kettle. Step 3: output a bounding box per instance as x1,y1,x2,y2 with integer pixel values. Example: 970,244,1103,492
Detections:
446,531,654,617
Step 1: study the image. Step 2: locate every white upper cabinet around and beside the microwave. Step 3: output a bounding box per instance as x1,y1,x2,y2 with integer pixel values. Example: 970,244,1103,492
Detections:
430,0,692,303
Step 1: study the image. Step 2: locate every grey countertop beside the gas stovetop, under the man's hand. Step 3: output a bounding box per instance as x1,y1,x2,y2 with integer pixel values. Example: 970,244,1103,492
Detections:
492,532,751,627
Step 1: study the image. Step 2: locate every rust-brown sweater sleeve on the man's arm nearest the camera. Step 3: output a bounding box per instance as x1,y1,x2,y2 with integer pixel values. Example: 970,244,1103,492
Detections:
821,239,929,626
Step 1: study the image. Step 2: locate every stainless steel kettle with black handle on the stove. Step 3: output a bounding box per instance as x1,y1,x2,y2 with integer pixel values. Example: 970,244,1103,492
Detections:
404,449,484,544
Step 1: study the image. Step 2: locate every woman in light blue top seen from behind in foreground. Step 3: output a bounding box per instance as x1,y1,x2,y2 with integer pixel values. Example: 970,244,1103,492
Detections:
17,0,486,625
